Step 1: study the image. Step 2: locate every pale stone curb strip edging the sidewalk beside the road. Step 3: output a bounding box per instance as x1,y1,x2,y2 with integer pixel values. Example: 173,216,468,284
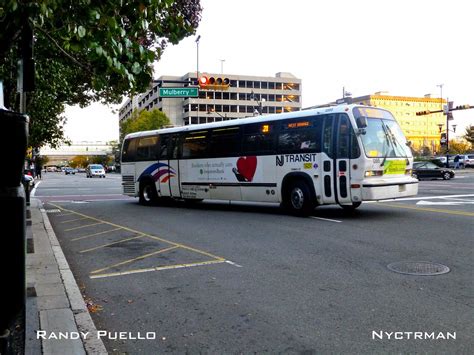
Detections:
36,198,108,354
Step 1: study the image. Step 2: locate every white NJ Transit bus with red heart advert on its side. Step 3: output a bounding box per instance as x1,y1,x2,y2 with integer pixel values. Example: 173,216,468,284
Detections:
121,105,418,215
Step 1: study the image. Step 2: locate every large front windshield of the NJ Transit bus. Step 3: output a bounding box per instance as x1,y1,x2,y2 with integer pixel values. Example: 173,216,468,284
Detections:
354,108,412,158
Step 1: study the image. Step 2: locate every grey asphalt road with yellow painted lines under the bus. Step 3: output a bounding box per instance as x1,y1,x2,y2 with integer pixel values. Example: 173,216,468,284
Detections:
35,169,474,354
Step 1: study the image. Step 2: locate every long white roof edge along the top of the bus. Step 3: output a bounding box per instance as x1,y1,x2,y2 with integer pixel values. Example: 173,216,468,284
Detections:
124,104,387,139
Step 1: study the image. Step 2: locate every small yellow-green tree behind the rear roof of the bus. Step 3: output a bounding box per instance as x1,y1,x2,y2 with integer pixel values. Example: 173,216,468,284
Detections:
120,109,171,141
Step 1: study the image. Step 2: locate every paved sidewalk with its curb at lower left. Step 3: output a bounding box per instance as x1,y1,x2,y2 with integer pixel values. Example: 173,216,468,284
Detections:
25,198,107,355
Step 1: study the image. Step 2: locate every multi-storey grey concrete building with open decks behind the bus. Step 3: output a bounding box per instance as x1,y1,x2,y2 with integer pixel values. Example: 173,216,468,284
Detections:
119,72,301,126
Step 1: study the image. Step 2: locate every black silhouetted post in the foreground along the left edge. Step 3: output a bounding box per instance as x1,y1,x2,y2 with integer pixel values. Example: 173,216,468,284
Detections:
0,19,34,354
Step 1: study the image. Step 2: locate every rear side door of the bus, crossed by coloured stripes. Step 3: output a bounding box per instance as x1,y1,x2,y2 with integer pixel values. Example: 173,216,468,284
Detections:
158,134,181,198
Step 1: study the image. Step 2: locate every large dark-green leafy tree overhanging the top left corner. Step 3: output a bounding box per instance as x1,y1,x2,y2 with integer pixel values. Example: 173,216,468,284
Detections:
0,0,202,147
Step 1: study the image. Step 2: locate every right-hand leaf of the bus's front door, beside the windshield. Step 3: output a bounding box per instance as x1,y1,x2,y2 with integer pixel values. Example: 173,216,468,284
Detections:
334,113,352,204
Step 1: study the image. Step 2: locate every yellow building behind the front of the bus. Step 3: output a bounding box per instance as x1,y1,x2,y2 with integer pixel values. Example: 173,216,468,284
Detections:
352,91,446,153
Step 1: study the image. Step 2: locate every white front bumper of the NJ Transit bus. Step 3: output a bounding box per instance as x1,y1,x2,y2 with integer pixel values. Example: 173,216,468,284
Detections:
362,178,418,201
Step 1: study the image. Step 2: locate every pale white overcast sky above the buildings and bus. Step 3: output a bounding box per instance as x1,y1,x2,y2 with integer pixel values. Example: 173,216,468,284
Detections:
65,0,474,141
